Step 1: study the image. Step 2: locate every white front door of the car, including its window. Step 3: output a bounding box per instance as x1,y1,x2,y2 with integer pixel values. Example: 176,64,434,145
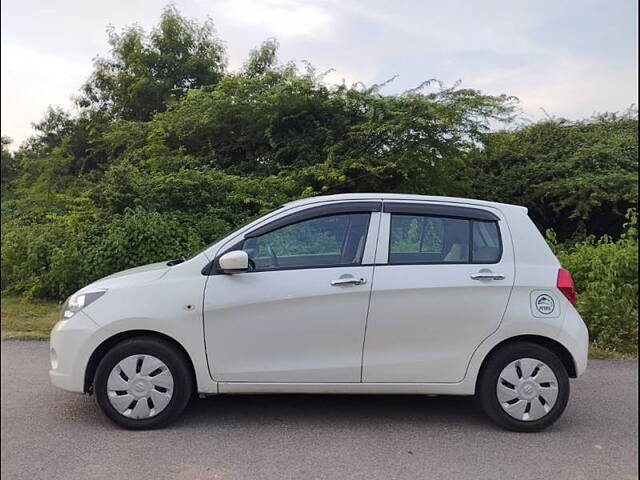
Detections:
204,202,380,382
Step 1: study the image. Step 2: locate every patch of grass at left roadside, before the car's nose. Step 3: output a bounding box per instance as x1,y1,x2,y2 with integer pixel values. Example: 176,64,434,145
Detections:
1,296,60,340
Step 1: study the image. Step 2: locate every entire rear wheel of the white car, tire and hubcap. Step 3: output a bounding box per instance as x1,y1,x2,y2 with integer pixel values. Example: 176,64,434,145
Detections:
477,342,569,432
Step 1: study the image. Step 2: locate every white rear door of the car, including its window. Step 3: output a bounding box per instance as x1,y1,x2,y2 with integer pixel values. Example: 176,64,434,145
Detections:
363,202,514,383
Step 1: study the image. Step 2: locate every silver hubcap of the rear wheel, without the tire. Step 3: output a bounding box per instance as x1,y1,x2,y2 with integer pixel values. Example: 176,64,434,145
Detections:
496,358,558,421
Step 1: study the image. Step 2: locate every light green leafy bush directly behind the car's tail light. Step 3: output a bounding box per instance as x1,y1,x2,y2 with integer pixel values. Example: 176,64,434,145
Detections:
548,211,638,353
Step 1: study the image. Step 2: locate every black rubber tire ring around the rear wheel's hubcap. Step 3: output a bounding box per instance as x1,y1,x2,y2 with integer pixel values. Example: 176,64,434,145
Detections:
476,342,569,432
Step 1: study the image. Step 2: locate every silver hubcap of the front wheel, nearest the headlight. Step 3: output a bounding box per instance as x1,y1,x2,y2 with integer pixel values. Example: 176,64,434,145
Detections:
107,355,173,419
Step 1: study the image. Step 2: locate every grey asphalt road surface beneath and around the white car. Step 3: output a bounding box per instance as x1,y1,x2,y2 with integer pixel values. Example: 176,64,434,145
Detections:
1,341,638,480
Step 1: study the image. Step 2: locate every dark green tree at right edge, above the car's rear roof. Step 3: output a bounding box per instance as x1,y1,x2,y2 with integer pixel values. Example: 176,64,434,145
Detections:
462,109,638,241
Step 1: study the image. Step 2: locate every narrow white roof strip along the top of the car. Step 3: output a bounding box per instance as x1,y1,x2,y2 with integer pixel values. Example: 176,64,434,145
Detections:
283,193,527,211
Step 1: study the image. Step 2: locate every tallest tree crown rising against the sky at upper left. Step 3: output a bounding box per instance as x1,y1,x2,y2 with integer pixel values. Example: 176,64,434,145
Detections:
78,6,226,121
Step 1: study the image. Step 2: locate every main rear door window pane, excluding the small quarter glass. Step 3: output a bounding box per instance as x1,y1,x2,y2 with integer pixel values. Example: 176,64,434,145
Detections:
389,214,470,264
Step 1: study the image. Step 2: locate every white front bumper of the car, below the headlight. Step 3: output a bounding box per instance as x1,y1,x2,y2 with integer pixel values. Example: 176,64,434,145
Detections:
49,311,109,393
